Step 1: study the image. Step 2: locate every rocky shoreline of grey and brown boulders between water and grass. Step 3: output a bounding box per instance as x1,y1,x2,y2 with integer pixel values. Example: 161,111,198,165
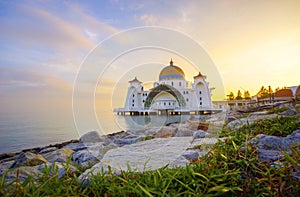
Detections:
0,106,300,182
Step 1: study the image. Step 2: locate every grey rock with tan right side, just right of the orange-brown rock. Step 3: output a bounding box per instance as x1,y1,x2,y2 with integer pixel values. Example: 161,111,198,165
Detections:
43,148,74,163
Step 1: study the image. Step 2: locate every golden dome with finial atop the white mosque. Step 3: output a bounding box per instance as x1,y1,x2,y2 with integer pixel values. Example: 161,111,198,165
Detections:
159,59,185,80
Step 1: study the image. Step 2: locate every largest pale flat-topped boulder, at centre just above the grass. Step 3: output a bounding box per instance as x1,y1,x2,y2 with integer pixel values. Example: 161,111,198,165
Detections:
79,137,193,180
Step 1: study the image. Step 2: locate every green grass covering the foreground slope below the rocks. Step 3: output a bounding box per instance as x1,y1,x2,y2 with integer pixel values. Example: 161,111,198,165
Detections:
0,116,300,196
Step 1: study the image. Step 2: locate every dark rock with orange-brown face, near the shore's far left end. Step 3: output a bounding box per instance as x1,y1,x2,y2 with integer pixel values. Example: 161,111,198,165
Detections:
11,152,47,168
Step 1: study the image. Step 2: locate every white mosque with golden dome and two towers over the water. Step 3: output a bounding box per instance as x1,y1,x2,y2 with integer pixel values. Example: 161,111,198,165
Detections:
116,59,220,115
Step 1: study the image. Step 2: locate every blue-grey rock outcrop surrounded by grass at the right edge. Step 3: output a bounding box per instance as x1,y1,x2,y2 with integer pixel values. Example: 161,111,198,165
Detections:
249,130,300,161
